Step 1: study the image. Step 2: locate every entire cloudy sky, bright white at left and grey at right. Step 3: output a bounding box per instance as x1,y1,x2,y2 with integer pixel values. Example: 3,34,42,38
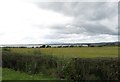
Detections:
0,0,119,44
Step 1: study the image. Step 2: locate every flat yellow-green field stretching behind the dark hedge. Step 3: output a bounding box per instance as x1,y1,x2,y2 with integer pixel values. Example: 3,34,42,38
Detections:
8,47,118,58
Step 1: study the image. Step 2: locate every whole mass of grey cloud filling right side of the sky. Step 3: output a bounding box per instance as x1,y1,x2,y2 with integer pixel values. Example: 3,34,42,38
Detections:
37,2,118,42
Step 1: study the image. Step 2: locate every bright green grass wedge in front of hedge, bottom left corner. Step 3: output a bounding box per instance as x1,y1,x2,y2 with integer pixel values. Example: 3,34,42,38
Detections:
2,68,56,80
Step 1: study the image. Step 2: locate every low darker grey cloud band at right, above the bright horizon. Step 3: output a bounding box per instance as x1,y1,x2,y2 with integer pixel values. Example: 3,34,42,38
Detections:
52,23,118,35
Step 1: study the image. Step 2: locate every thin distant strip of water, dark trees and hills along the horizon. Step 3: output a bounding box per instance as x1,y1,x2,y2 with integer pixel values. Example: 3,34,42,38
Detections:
0,42,120,48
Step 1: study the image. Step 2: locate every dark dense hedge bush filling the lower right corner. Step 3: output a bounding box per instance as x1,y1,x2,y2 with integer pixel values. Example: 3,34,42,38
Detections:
64,58,119,82
